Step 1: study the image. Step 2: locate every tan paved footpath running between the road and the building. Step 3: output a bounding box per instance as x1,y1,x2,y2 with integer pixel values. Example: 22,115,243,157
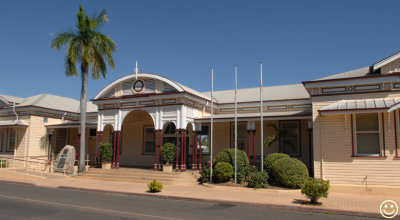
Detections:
0,170,400,219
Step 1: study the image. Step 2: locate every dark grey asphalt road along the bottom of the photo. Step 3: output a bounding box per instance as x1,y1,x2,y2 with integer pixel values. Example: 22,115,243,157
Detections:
0,182,378,220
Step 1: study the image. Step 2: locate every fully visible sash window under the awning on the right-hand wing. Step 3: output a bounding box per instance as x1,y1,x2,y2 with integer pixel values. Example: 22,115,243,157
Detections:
355,113,381,156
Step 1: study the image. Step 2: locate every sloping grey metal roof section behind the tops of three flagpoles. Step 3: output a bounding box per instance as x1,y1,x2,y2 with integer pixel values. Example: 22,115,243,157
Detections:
203,84,310,104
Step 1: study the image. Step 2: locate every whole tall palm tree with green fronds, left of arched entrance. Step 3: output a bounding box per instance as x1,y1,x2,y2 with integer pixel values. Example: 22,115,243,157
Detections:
51,4,117,172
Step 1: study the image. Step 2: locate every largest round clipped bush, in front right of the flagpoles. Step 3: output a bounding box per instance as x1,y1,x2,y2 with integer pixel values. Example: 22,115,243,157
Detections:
271,158,308,189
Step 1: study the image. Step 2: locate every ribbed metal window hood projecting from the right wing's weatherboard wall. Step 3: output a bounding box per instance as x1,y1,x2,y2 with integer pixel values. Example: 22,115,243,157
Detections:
319,98,400,112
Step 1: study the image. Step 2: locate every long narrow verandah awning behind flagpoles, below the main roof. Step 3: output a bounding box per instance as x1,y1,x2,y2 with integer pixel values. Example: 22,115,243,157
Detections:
194,111,312,122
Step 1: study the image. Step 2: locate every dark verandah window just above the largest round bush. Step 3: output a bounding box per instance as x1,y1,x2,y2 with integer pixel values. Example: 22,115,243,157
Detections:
279,121,301,157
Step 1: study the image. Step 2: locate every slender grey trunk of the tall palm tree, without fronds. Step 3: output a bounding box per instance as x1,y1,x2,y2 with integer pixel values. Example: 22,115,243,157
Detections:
78,64,89,173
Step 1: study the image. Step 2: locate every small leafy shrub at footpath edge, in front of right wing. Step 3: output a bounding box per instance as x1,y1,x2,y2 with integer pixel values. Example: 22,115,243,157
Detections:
301,177,329,204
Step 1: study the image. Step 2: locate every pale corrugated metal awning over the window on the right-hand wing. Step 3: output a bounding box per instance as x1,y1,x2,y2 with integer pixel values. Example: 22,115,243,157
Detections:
318,98,400,115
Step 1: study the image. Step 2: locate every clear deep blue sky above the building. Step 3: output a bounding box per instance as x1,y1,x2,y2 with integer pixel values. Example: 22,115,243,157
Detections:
0,0,400,99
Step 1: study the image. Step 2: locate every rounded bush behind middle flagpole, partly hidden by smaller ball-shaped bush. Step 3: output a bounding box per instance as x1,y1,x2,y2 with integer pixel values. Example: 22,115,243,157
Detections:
215,148,249,171
